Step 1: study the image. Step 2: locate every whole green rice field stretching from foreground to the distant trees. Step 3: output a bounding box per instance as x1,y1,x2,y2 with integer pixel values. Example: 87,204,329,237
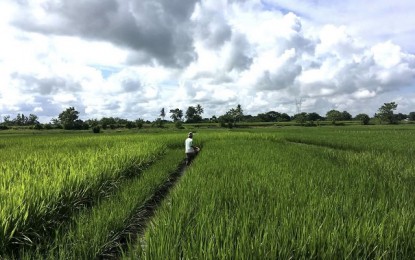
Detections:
0,126,415,259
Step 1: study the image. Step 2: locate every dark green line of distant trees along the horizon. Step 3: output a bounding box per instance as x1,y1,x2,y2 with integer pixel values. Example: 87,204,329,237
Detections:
0,102,415,132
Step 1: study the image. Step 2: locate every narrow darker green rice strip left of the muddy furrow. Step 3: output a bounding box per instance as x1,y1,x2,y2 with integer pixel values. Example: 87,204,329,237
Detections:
14,149,183,259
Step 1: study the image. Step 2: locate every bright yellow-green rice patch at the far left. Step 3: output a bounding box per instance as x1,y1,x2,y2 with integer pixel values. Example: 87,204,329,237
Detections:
0,135,167,255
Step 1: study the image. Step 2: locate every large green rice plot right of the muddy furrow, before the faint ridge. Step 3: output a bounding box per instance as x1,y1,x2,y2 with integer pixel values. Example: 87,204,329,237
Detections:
126,133,415,259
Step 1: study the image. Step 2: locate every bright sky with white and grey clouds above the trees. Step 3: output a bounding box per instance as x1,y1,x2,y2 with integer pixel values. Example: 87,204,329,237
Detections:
0,0,415,122
